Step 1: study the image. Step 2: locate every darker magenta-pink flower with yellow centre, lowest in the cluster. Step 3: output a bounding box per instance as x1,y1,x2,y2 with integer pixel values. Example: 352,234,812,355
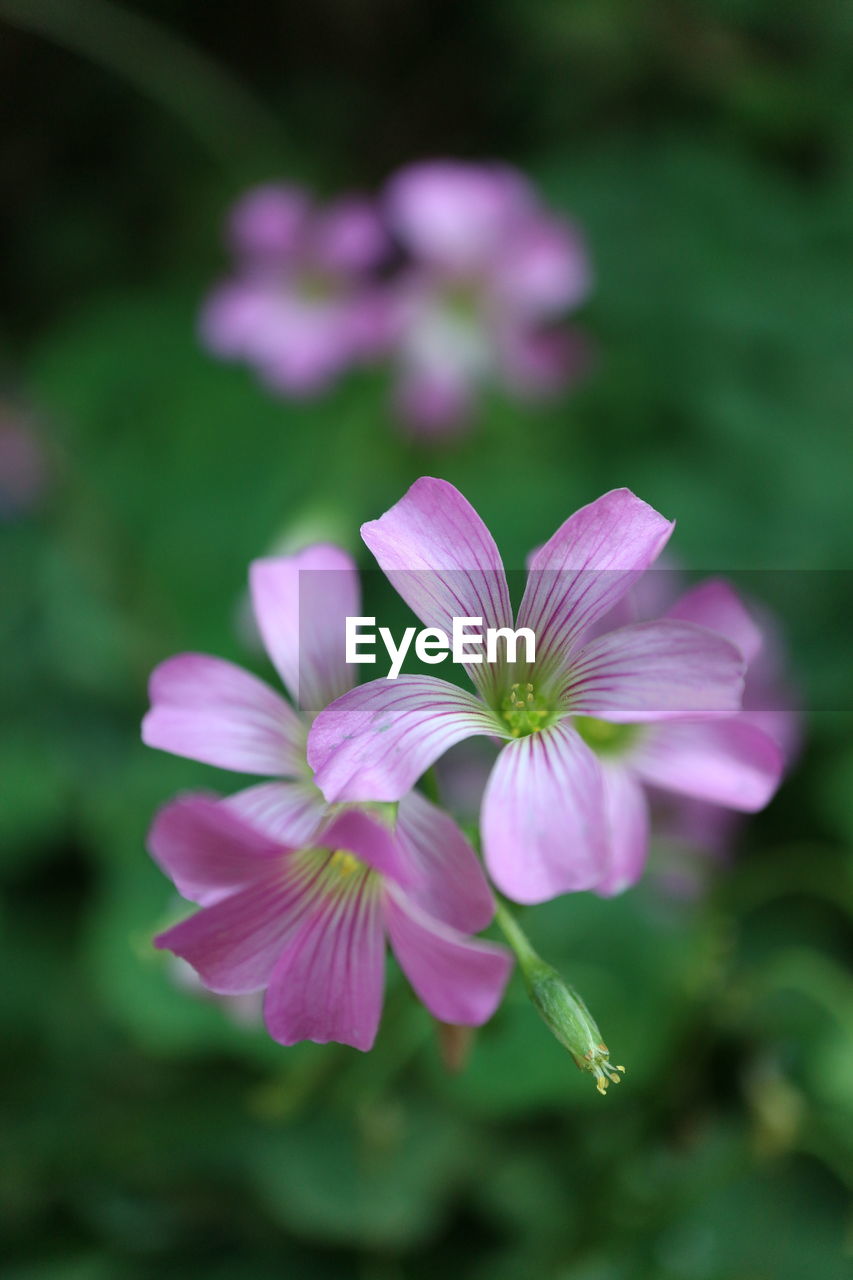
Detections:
150,796,512,1050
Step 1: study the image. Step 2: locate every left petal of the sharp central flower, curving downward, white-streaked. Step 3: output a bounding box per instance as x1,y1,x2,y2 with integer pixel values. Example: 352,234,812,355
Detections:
307,676,503,801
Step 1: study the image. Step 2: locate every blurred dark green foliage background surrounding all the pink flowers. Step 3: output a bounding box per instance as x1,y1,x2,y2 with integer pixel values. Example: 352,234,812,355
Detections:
0,0,853,1280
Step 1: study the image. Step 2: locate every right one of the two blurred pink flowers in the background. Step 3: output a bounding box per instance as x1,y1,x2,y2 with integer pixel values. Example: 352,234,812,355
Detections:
386,160,589,434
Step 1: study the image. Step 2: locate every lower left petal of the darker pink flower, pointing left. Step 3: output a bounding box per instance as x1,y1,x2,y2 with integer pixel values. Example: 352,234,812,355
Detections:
154,858,323,996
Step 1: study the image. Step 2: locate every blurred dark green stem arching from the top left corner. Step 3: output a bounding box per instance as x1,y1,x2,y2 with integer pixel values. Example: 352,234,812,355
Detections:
0,0,282,164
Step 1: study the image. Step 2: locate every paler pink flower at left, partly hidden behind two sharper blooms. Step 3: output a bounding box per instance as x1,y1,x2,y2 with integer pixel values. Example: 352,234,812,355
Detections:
142,544,494,952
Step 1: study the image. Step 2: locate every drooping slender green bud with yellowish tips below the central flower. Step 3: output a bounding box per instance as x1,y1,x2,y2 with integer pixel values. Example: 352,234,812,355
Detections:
494,899,625,1093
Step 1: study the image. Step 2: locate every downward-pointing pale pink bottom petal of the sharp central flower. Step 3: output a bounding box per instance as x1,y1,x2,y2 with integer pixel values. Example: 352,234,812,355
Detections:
480,721,607,902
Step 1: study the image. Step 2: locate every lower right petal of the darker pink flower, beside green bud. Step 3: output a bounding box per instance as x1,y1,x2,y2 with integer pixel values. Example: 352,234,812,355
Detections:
384,890,512,1027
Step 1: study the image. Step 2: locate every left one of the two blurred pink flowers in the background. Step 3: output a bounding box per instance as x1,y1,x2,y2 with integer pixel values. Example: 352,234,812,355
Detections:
201,184,389,396
